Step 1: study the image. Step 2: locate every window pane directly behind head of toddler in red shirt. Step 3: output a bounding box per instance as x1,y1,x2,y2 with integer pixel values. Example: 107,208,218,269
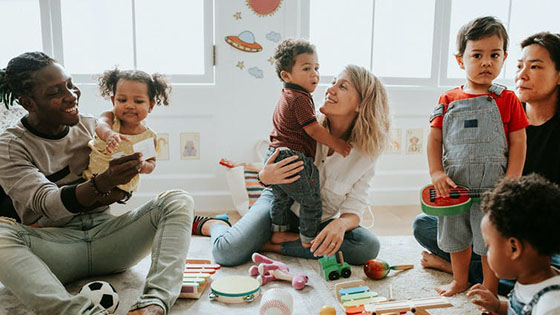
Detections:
447,0,509,78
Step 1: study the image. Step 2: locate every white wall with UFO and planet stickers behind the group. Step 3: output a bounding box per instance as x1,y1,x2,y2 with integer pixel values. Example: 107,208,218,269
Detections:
76,0,443,211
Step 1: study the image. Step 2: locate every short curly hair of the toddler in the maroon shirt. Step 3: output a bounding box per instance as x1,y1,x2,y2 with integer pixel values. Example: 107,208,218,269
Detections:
273,39,315,80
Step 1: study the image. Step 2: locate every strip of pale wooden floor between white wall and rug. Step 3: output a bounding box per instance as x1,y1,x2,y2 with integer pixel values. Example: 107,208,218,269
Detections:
197,205,421,235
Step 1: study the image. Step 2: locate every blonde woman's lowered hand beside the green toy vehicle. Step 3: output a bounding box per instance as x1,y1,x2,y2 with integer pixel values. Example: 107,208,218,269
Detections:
310,218,346,257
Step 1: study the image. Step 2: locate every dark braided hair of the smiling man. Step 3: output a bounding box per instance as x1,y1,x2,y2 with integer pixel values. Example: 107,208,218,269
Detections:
0,51,56,109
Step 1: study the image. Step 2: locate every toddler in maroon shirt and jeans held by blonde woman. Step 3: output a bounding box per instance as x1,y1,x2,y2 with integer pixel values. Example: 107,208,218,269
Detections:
266,39,350,247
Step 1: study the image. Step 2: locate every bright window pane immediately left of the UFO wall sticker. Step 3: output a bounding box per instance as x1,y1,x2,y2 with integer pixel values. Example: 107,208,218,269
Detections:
136,0,204,74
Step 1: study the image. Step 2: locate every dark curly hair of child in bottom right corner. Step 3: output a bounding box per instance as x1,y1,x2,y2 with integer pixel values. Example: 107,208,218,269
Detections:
480,174,560,256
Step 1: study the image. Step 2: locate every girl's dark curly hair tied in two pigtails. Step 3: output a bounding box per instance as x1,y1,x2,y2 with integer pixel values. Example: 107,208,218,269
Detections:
99,68,171,105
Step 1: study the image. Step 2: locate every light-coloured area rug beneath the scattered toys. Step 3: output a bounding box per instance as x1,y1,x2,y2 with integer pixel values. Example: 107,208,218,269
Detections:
0,236,480,315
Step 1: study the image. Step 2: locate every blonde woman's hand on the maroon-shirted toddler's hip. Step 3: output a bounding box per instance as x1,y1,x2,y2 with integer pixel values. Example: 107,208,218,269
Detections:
259,149,303,185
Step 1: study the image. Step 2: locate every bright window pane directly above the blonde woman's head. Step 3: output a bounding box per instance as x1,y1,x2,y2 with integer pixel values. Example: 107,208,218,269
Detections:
309,0,373,75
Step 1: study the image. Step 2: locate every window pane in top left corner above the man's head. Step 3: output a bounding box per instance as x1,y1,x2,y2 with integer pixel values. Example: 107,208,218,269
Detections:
0,0,43,68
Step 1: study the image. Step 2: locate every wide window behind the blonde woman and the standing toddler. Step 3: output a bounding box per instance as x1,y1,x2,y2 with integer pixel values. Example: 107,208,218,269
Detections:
308,0,560,86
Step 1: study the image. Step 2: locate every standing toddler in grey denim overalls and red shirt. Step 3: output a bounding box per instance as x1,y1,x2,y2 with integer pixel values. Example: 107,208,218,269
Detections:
428,17,528,296
